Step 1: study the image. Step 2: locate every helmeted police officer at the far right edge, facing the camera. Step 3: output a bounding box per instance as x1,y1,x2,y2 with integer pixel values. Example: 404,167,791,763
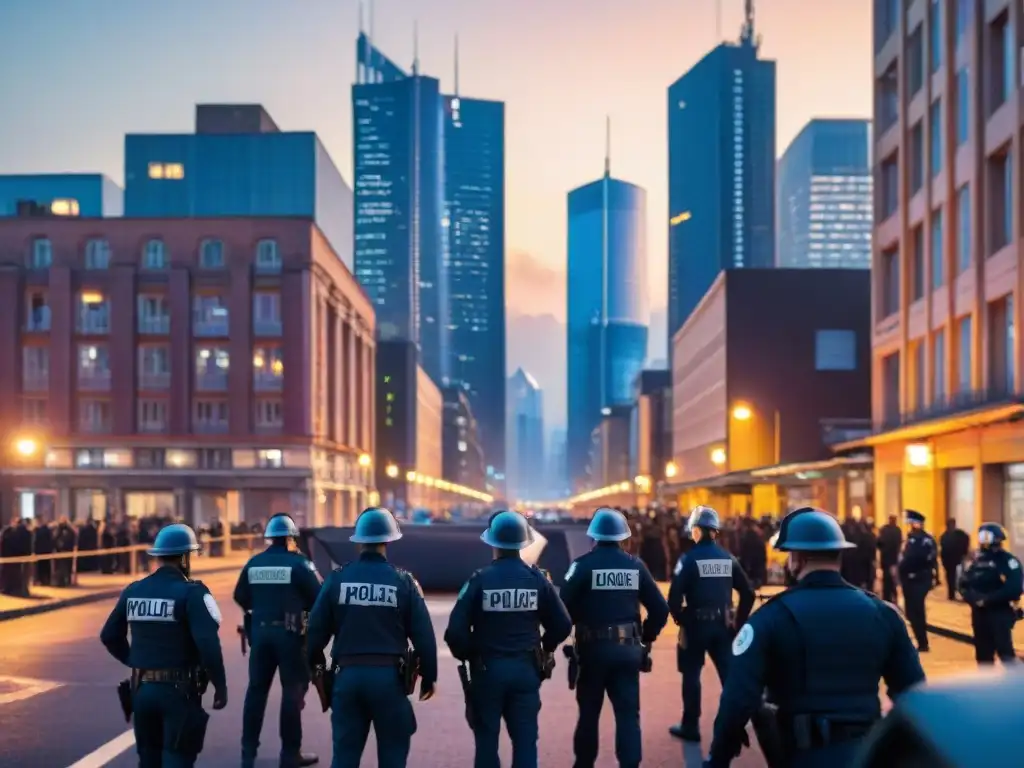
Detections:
959,522,1024,665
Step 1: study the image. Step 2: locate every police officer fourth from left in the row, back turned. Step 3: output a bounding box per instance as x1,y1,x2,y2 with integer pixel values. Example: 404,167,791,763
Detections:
444,512,572,768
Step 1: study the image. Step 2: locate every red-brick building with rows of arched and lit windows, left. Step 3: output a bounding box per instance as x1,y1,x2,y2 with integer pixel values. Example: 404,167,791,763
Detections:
0,216,375,525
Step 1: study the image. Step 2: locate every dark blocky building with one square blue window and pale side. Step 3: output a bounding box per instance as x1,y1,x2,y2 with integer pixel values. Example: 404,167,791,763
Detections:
672,268,870,512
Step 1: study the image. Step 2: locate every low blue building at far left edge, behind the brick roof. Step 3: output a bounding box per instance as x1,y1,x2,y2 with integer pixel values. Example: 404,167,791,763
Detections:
0,173,124,218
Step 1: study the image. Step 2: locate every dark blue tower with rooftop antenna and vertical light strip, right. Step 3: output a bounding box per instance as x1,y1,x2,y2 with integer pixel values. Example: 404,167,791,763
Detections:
669,0,775,339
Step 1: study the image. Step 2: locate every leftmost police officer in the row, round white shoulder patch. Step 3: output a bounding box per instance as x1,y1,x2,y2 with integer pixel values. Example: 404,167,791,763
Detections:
99,524,227,768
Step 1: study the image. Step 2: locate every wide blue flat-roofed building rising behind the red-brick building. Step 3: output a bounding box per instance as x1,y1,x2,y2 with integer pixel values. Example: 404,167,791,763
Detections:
124,104,352,270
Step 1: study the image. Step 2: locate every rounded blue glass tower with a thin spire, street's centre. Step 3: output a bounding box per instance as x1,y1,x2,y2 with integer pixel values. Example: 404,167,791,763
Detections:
567,131,650,483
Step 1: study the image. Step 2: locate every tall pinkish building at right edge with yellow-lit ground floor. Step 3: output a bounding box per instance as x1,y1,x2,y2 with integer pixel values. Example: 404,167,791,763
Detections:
859,0,1024,555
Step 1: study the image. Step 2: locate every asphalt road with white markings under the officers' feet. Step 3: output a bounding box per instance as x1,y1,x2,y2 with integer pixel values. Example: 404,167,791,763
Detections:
0,573,974,768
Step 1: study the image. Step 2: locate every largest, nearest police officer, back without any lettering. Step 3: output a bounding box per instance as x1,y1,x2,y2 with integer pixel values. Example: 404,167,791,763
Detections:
705,507,925,768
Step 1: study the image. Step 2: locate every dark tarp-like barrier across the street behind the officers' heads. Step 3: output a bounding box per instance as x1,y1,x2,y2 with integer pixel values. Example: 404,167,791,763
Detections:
300,524,591,592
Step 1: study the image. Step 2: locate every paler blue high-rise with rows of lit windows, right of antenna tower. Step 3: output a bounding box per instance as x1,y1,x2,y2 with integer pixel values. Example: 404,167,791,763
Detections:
775,118,873,269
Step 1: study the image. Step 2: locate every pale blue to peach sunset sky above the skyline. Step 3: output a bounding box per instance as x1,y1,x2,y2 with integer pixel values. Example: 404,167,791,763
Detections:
0,0,871,434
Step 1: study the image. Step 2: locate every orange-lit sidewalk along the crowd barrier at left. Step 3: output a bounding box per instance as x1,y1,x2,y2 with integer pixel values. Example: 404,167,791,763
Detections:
0,550,253,622
